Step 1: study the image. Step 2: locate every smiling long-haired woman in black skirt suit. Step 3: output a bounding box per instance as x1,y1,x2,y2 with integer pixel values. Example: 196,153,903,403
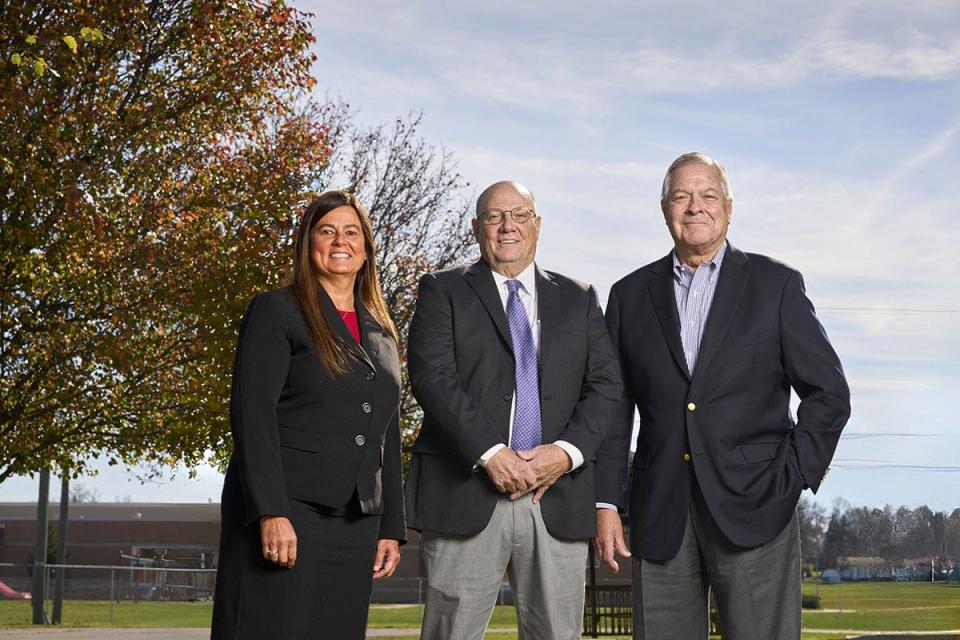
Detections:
212,191,406,640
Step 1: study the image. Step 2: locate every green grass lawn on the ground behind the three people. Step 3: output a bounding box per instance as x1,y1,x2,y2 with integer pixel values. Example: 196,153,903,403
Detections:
0,582,960,640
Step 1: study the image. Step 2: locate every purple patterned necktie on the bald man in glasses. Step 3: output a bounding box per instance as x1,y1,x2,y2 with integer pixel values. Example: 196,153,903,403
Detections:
507,280,540,451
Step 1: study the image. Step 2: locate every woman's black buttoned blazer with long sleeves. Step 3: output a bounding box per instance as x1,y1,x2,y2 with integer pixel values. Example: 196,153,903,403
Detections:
224,287,406,541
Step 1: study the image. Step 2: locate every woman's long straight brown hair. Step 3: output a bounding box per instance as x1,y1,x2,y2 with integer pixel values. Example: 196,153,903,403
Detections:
293,191,399,373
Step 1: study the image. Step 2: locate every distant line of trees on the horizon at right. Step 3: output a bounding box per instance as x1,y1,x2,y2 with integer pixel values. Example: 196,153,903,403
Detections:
797,498,960,569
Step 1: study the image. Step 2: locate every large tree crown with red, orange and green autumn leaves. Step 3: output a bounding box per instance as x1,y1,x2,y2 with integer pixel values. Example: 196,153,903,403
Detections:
0,0,330,481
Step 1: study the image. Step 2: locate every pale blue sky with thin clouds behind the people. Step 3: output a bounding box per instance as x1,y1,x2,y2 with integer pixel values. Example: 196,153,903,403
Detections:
0,0,960,509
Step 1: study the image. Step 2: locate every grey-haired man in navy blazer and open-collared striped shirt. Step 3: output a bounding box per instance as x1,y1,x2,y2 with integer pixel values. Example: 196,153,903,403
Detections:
596,153,850,640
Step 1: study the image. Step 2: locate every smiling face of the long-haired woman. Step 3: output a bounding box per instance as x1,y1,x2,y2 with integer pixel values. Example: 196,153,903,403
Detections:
310,205,367,279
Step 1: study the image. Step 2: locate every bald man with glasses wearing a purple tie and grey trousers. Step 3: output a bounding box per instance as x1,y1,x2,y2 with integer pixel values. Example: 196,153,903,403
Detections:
405,182,621,640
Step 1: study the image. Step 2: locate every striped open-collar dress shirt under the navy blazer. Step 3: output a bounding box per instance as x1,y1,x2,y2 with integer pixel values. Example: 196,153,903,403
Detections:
673,240,727,376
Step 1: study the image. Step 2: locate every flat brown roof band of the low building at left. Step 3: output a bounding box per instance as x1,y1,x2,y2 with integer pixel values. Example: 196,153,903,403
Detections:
0,502,220,522
